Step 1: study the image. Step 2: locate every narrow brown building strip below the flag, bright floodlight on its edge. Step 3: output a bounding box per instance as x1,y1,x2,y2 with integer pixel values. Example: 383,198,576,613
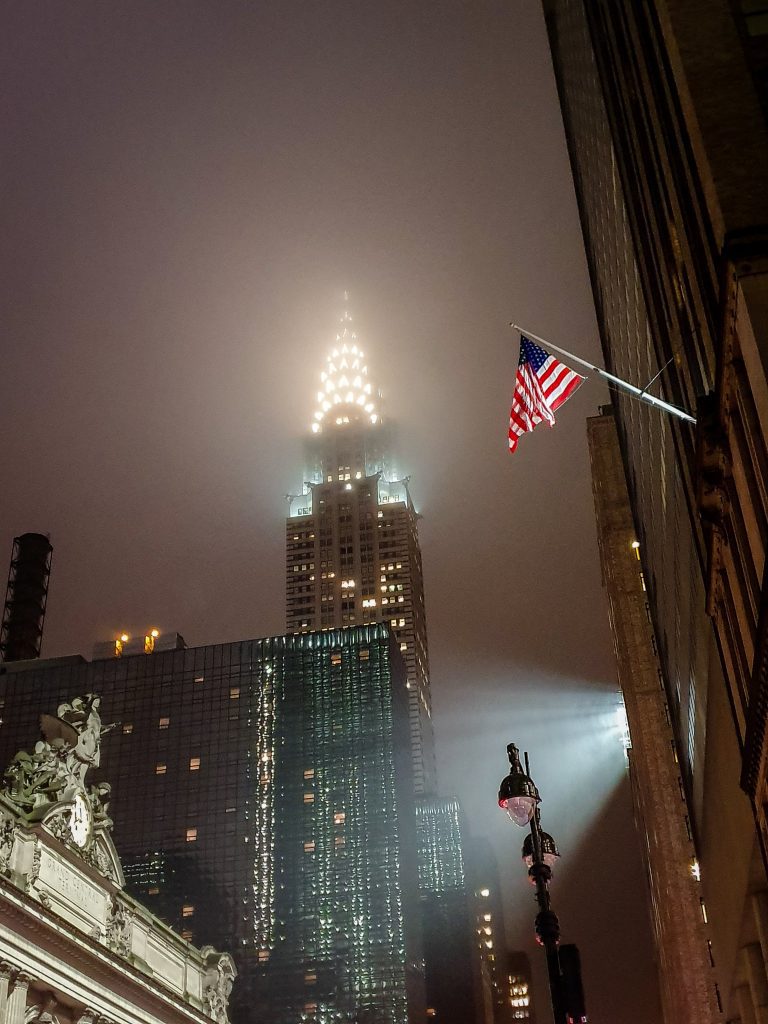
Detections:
587,409,719,1021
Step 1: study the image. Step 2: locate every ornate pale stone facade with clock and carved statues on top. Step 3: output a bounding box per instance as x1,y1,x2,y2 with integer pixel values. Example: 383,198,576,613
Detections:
0,694,237,1024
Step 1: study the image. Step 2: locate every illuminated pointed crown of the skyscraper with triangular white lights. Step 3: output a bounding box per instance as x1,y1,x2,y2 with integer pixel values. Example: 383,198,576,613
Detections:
312,312,379,434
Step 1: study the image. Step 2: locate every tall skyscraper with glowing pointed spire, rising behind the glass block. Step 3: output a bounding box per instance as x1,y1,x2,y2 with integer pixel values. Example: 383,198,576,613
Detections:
286,303,435,794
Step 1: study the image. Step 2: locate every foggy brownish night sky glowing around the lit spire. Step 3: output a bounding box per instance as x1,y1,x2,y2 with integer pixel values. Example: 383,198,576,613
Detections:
0,0,658,1024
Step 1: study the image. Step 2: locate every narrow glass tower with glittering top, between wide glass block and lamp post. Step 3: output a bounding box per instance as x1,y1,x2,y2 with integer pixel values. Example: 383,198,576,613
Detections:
416,797,493,1024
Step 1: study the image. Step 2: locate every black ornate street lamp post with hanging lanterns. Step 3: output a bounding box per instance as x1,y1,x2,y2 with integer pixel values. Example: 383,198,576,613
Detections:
499,743,587,1024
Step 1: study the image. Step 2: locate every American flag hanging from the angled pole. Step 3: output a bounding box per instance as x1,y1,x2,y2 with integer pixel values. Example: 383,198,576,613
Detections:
509,335,584,452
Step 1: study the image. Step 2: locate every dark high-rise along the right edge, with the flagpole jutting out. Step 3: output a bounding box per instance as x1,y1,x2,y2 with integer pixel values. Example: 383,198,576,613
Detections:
544,0,768,1020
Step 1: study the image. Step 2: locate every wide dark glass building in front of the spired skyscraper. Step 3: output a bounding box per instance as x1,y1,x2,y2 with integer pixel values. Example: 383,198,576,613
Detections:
0,624,424,1024
